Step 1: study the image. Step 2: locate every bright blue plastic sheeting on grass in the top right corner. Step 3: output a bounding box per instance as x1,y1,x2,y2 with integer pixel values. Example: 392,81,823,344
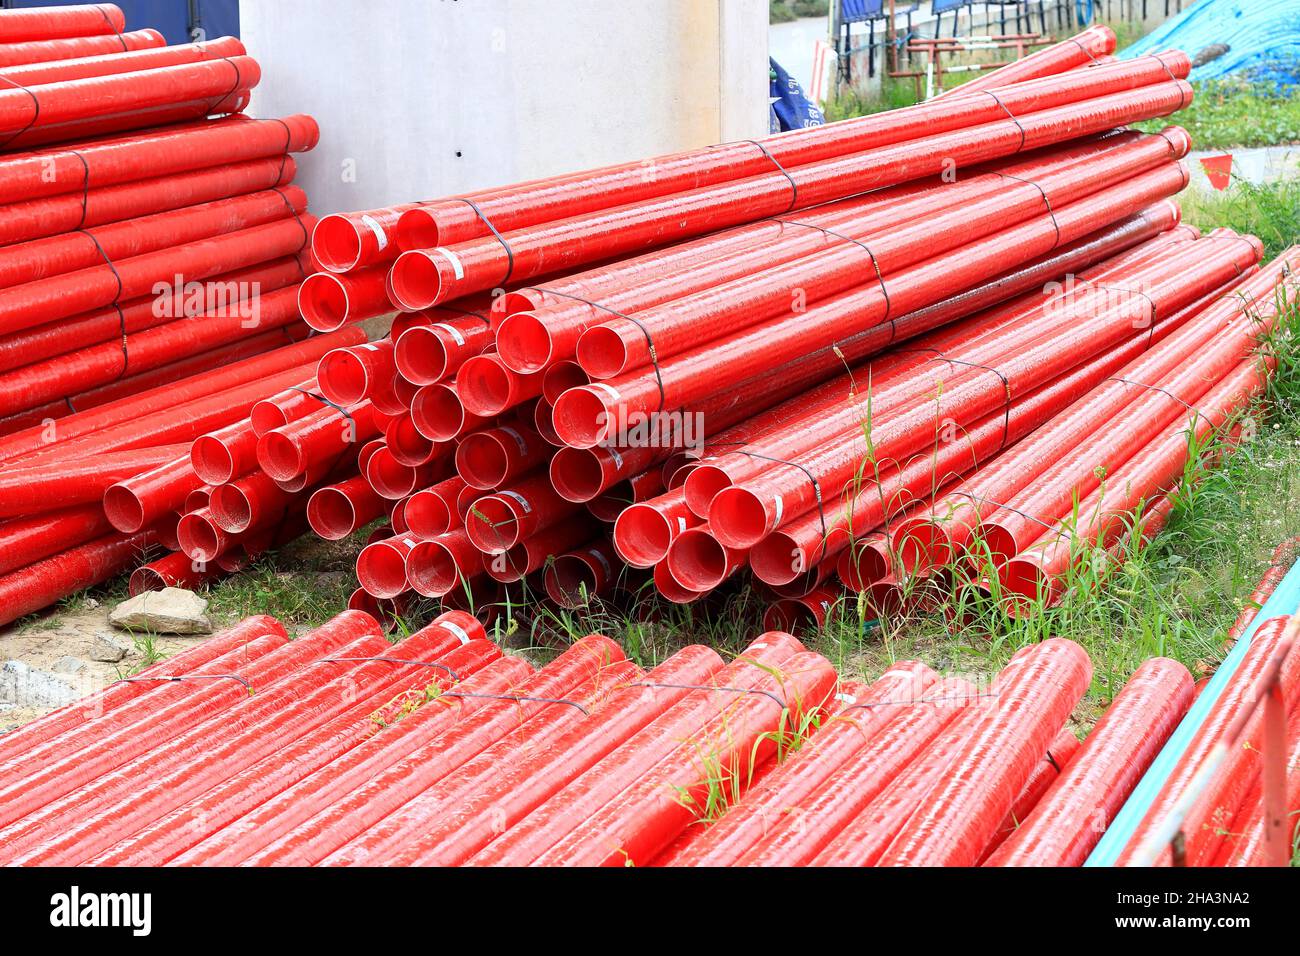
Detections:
1119,0,1300,86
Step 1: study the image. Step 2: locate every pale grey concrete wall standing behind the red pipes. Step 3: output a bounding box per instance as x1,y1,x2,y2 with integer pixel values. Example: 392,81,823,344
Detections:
239,0,768,213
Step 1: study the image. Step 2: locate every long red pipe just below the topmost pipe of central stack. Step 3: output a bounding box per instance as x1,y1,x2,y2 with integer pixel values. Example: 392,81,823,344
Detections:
391,72,1192,310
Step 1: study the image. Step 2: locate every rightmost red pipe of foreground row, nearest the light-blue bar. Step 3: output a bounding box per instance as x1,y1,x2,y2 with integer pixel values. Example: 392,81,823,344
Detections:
984,657,1192,866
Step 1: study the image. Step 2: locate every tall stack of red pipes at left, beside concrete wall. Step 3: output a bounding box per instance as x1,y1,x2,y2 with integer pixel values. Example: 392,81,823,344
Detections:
0,4,332,622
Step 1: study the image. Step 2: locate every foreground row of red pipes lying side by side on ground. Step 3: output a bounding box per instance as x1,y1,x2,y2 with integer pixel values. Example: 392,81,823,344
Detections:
10,621,1295,866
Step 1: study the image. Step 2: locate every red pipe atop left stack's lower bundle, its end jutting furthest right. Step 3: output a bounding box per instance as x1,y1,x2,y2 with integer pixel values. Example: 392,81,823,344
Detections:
0,114,320,206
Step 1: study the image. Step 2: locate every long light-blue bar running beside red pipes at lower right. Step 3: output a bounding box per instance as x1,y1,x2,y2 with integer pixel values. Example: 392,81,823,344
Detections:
1083,546,1300,866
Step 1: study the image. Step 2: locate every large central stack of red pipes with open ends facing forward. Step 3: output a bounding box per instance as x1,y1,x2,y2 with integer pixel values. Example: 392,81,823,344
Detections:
282,31,1281,626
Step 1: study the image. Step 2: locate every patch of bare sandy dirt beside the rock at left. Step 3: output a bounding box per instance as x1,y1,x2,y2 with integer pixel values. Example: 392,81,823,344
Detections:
0,602,207,734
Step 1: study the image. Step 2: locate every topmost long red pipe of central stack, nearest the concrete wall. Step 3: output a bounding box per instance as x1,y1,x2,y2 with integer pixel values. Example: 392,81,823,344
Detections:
387,55,1190,261
